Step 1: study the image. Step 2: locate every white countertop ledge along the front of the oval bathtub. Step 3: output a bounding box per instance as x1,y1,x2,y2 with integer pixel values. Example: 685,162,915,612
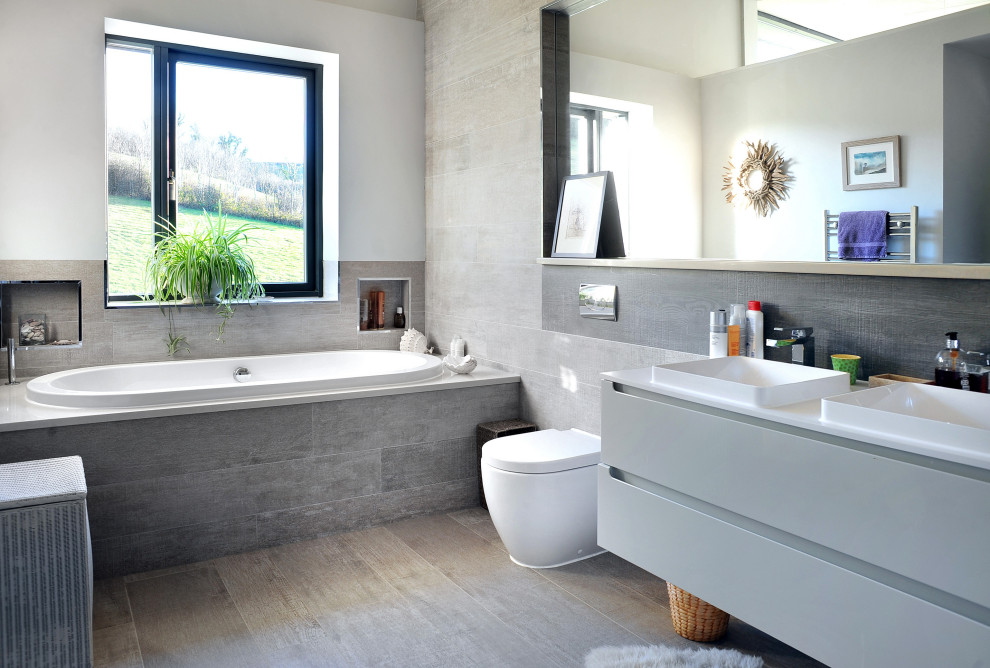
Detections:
0,366,519,434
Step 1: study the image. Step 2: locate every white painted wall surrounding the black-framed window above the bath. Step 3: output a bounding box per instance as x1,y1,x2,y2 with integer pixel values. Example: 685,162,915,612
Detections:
0,0,426,260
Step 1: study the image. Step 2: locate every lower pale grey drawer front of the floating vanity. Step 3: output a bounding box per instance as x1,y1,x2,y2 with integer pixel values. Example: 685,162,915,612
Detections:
598,464,990,668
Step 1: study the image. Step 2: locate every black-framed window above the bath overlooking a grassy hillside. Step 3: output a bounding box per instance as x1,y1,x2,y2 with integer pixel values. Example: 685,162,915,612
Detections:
106,36,322,301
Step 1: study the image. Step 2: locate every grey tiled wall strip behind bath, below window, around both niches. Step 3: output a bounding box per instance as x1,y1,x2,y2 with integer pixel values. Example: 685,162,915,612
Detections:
0,260,426,378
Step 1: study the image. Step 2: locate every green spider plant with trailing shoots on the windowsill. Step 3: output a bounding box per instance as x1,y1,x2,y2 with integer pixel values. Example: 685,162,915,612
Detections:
145,206,265,356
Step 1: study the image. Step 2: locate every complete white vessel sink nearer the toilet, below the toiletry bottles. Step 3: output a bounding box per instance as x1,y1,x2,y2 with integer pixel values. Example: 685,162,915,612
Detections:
652,357,849,408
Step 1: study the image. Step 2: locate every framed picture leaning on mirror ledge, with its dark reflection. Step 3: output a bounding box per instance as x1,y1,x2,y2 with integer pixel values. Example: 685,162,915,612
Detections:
550,172,625,258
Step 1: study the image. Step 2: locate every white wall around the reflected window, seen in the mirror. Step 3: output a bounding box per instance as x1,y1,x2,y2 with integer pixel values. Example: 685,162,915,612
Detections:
570,51,701,258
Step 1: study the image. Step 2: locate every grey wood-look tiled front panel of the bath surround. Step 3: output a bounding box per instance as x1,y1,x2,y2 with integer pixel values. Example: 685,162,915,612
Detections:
0,383,519,577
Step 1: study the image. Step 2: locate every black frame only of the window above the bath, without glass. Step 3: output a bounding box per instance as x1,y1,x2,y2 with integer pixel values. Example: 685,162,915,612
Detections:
104,33,324,305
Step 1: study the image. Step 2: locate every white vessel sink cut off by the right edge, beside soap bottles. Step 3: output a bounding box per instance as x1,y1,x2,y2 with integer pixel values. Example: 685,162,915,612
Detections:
822,383,990,454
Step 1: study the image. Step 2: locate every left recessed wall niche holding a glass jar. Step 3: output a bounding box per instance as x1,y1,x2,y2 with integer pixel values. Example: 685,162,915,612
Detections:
0,281,82,350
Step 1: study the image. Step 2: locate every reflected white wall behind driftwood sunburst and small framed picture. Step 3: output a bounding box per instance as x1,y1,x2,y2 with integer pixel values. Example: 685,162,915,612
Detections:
701,7,990,262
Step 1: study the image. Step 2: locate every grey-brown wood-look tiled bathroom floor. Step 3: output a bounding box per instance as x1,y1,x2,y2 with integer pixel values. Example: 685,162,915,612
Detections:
94,508,822,668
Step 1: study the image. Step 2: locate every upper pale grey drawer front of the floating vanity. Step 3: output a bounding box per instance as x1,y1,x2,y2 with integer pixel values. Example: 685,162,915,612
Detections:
602,381,990,612
